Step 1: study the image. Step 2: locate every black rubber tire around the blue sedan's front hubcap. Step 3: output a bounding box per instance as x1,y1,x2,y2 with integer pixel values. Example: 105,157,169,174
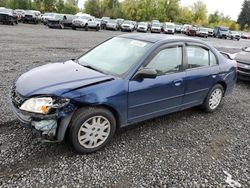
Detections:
67,107,116,154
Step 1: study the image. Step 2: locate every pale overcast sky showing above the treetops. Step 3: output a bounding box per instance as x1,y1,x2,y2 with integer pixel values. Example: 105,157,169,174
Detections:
79,0,244,21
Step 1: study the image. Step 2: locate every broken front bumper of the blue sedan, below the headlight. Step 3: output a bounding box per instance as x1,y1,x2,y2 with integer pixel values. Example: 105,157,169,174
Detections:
11,98,75,142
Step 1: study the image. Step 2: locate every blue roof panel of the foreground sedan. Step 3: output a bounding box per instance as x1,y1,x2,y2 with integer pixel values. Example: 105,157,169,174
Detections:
119,33,204,43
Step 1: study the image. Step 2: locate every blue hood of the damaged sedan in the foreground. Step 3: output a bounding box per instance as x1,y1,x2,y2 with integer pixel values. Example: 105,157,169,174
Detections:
15,61,114,97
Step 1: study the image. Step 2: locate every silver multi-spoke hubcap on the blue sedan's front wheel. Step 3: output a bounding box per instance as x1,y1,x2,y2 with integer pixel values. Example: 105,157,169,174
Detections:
78,116,111,148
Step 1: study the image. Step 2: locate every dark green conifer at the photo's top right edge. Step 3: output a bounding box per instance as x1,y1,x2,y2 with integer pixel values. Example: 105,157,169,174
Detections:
238,0,250,30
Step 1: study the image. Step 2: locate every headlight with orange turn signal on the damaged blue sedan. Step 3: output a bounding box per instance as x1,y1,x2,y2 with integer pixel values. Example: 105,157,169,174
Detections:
20,97,53,114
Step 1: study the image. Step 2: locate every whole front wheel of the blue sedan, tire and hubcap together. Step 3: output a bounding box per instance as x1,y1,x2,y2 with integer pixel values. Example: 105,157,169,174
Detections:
68,107,116,154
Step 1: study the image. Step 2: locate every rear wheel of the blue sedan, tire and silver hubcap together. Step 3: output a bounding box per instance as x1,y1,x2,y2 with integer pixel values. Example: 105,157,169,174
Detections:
203,84,224,112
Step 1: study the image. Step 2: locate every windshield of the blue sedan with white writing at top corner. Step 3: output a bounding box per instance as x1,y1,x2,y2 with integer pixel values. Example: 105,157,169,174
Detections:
78,37,152,76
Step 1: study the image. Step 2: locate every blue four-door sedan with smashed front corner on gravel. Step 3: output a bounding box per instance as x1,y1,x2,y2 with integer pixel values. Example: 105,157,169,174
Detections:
11,34,237,154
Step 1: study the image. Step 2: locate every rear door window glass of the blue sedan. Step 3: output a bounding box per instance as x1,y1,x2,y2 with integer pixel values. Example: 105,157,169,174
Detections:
186,46,209,69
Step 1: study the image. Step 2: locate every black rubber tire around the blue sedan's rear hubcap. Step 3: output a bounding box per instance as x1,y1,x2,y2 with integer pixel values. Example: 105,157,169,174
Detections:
202,84,224,113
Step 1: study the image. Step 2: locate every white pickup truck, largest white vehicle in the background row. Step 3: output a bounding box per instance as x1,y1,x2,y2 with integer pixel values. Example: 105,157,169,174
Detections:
72,14,100,31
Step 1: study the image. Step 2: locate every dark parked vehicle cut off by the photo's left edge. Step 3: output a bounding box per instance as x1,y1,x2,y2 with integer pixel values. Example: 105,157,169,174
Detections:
0,8,18,25
